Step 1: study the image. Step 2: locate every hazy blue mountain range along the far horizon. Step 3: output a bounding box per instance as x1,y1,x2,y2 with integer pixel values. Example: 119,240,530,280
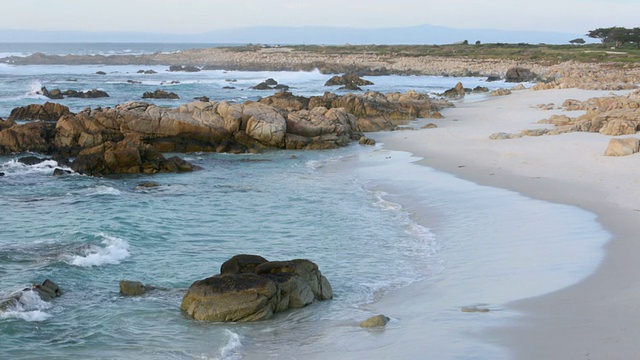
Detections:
0,25,590,45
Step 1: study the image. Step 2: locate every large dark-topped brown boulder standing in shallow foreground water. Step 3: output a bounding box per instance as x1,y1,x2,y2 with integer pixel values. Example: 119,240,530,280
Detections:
180,254,333,322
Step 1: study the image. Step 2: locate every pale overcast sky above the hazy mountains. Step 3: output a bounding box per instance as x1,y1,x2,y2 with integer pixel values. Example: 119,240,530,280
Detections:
0,0,640,34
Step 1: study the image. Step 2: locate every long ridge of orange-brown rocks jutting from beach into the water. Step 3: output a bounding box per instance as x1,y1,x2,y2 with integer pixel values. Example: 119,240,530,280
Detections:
0,91,451,175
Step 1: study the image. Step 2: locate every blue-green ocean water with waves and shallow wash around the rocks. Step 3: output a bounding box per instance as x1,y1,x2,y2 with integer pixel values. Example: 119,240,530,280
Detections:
0,44,609,359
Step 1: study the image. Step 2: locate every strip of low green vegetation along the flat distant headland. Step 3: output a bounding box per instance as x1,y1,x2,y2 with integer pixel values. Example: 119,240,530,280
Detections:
226,39,640,65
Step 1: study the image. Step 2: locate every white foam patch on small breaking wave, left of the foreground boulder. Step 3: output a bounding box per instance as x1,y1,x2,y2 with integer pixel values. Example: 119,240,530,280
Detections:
68,234,130,267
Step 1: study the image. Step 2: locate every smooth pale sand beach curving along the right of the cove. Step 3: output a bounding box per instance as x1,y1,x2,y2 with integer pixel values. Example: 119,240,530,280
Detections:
371,89,640,359
